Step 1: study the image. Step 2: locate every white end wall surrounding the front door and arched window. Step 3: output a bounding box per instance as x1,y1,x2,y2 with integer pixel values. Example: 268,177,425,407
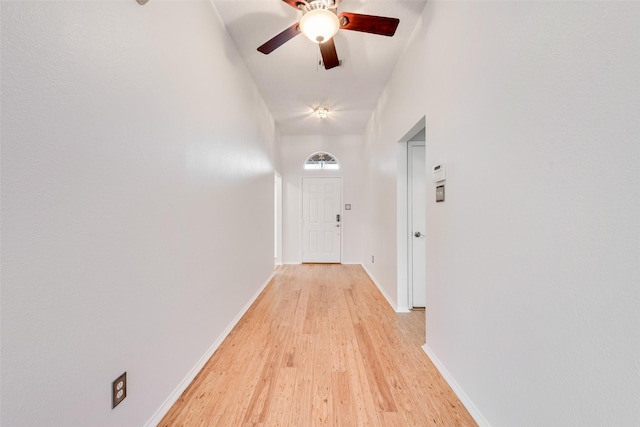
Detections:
281,135,365,264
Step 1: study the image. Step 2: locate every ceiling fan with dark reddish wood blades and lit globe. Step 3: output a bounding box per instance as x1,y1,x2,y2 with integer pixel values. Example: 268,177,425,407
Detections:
258,0,400,70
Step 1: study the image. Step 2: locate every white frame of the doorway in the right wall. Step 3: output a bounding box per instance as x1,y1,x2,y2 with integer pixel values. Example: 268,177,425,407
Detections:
396,116,428,313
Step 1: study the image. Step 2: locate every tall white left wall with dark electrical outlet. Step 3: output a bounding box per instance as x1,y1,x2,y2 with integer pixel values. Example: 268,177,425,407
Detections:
0,0,277,426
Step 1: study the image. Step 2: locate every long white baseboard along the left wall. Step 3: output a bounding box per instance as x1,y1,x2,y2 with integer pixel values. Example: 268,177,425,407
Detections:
145,272,275,427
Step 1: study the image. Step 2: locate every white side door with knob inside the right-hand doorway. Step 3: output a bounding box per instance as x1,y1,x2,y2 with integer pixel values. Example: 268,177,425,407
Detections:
409,143,427,307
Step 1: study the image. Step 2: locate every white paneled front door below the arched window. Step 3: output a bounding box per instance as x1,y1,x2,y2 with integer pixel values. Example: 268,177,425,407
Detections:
302,178,342,263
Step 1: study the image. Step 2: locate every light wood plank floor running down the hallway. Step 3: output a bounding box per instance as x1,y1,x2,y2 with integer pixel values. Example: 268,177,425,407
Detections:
159,264,476,427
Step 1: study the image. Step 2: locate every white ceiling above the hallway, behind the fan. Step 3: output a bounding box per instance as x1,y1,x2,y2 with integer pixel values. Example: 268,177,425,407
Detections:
213,0,425,135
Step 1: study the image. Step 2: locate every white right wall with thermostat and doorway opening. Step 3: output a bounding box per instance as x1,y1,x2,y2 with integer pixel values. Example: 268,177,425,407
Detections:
364,1,640,427
